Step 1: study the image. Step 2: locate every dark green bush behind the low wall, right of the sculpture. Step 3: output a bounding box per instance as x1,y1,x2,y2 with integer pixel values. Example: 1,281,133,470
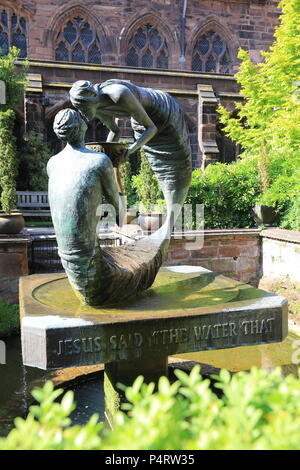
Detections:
186,159,260,229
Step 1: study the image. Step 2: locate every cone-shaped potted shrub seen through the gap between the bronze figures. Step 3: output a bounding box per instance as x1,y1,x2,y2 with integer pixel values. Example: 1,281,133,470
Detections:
132,150,165,232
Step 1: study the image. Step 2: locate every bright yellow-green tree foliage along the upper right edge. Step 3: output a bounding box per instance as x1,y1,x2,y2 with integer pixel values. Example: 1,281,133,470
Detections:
219,0,300,228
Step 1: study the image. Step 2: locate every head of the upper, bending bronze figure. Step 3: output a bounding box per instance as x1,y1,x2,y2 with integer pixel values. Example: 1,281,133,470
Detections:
70,80,98,120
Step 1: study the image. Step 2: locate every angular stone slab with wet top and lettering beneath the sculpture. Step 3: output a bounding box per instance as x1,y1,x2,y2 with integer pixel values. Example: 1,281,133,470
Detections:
20,266,287,369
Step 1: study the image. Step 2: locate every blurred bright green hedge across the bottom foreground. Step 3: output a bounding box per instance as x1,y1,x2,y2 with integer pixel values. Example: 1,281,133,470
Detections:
0,367,300,450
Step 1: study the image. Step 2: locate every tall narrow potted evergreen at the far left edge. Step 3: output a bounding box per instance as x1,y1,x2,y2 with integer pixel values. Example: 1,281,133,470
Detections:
0,47,28,234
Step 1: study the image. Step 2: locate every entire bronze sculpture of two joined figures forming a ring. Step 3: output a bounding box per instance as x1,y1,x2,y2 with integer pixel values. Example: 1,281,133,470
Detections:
48,80,191,305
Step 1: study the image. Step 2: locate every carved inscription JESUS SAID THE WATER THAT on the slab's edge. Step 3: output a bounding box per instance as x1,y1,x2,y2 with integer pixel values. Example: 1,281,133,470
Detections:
56,317,275,360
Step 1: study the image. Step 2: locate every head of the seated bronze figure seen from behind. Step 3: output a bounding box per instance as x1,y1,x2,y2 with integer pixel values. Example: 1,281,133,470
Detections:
53,108,87,146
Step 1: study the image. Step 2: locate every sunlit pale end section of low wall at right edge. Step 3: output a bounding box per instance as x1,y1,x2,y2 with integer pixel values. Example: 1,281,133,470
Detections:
260,228,300,282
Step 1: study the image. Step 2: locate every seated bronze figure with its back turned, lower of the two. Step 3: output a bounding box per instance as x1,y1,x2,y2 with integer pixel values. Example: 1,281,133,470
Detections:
47,109,168,305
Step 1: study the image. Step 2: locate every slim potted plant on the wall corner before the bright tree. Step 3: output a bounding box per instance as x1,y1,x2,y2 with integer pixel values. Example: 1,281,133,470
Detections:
253,139,277,227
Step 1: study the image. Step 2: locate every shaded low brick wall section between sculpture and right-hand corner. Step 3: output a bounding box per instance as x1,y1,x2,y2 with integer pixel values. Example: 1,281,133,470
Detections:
165,229,261,285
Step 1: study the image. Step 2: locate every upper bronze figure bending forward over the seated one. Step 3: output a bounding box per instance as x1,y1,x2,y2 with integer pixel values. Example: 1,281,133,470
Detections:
70,80,192,230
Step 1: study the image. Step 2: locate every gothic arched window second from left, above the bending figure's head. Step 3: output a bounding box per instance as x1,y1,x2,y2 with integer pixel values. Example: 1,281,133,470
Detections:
55,17,101,64
